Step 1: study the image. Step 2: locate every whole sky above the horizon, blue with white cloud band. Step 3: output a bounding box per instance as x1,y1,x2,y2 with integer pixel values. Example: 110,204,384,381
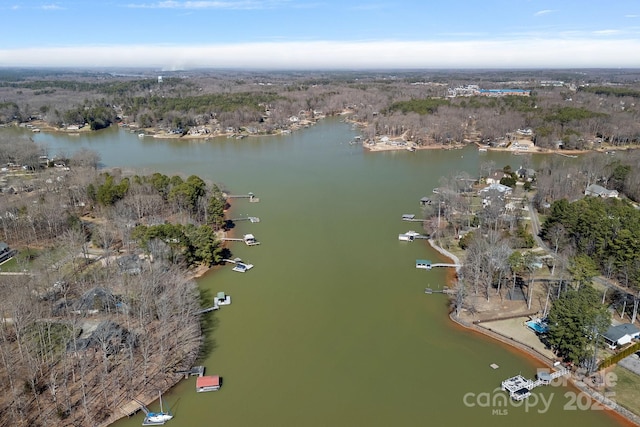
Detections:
0,0,640,70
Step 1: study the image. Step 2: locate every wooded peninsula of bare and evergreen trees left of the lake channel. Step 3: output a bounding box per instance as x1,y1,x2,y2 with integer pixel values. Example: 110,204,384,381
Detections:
0,135,234,426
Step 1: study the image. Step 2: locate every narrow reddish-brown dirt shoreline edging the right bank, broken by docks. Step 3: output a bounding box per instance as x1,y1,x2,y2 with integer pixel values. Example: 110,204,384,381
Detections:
428,239,640,426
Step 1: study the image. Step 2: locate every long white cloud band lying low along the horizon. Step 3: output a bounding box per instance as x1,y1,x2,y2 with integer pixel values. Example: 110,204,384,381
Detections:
0,38,640,69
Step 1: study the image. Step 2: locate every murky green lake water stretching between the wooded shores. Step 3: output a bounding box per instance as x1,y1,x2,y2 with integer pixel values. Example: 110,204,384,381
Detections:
18,119,621,427
